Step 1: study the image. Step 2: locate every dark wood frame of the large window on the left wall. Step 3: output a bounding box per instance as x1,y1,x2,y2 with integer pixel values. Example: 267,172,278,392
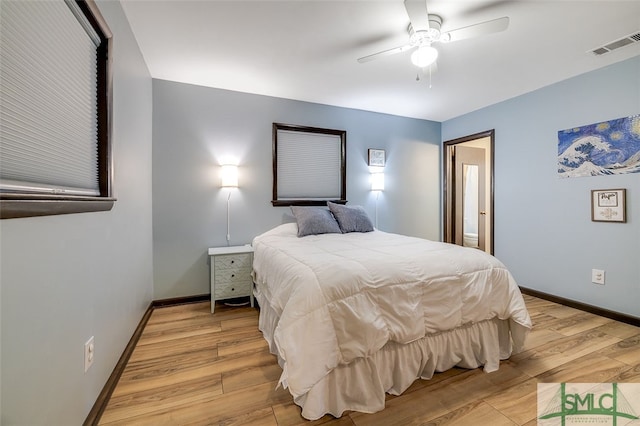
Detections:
0,0,115,219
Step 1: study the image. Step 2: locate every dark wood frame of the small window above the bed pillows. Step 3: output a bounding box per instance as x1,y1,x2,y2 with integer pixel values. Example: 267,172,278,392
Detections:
271,123,347,207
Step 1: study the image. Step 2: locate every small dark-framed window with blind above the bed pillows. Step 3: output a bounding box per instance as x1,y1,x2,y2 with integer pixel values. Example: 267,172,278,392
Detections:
271,123,347,206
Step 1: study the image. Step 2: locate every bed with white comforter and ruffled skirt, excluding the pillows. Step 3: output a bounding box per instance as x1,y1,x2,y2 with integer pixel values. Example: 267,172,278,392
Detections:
253,206,531,420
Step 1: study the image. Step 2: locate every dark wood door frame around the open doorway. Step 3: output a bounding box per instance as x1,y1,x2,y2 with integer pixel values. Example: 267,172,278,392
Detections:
442,129,495,254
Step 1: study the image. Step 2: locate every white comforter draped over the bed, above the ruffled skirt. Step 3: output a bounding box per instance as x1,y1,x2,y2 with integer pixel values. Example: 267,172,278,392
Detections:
253,223,531,398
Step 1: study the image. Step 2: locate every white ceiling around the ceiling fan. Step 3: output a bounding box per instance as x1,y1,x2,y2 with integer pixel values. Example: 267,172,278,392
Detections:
121,0,640,121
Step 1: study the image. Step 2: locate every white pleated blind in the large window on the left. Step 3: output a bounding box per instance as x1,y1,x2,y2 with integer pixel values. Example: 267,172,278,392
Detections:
0,0,100,195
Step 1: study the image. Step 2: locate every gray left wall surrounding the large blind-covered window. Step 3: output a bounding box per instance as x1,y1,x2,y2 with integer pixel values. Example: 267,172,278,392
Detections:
0,1,153,426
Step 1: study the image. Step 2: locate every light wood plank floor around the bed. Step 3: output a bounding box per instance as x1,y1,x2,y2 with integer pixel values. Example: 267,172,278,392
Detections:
100,296,640,426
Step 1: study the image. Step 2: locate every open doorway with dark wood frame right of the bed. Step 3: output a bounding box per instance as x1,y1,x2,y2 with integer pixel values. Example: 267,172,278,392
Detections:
443,130,495,254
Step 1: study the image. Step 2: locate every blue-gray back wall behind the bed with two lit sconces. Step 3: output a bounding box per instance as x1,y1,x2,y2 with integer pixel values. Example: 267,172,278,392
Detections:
153,80,441,299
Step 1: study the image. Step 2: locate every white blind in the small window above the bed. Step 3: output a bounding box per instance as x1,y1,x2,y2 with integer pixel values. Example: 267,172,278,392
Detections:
277,129,342,200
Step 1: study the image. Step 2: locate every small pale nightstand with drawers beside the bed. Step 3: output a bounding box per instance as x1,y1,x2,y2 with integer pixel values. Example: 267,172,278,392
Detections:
209,245,253,313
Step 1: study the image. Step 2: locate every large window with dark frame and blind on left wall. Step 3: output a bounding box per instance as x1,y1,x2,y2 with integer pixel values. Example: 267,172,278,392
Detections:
0,0,115,219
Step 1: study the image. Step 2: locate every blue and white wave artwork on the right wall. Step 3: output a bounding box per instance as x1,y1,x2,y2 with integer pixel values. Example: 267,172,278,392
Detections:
558,115,640,177
